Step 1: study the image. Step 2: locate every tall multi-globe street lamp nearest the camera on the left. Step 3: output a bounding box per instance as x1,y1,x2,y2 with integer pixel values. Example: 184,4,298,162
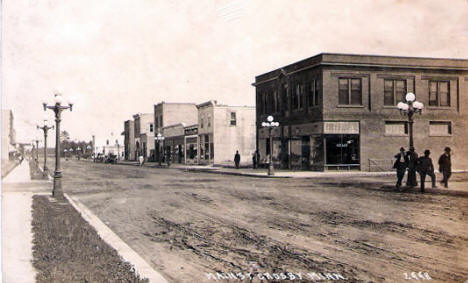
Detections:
42,92,73,197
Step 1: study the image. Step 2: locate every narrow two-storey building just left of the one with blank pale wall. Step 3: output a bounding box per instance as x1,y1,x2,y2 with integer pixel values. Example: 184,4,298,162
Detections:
133,113,154,160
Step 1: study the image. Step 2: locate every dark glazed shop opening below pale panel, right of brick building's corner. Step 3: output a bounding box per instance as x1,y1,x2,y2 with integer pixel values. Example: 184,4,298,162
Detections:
324,134,360,170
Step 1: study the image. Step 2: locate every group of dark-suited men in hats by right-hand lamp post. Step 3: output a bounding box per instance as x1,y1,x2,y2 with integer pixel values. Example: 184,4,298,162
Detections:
393,147,452,193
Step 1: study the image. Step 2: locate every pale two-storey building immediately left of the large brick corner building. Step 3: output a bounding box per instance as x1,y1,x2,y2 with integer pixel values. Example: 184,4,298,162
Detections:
197,101,255,165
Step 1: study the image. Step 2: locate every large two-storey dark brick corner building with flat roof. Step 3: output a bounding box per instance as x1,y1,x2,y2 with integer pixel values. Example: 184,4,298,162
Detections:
253,53,468,171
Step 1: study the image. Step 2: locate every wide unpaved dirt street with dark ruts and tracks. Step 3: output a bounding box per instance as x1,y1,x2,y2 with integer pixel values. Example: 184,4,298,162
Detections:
55,161,468,282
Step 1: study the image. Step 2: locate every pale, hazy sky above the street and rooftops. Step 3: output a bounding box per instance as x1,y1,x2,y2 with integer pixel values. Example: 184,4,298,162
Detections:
1,0,468,144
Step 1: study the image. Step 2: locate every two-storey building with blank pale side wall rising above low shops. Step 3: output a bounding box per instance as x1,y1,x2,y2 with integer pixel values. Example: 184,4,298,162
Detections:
153,101,198,160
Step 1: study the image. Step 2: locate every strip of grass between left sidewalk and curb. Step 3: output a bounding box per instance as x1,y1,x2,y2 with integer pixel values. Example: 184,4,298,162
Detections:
32,195,148,282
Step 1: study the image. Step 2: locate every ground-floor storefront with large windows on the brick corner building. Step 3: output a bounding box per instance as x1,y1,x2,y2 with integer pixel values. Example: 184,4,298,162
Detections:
258,121,360,171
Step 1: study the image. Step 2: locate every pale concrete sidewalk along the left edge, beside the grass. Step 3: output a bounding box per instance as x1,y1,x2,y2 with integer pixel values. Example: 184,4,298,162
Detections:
2,161,50,283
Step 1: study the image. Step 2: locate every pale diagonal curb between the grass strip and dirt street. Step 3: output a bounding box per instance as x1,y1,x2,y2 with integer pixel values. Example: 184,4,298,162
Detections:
64,194,167,283
